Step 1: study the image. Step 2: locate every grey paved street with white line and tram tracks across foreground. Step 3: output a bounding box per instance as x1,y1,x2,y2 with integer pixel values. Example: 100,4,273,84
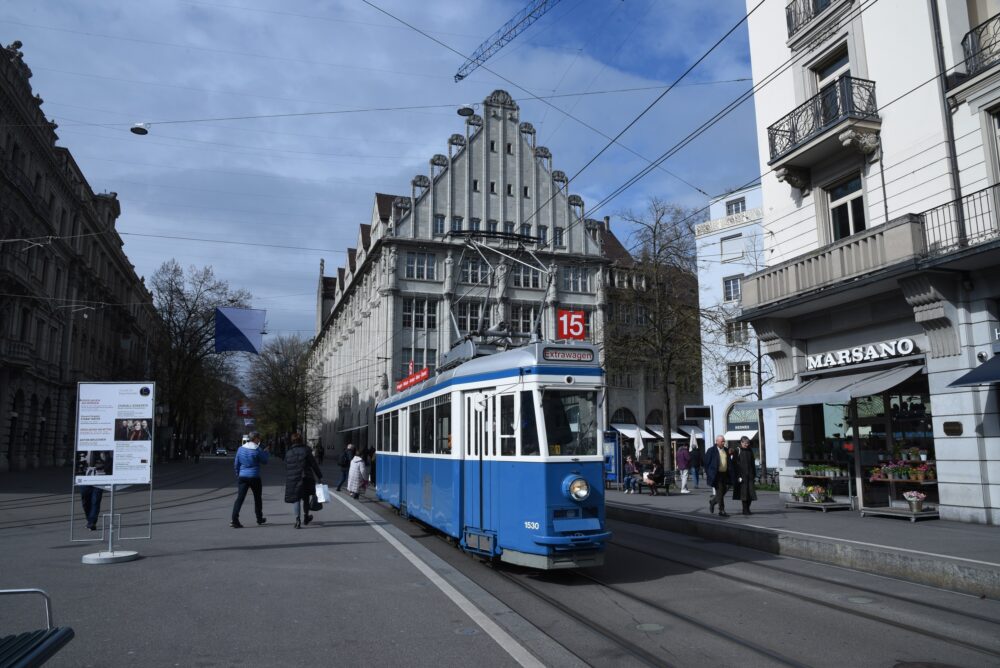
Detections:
0,458,1000,666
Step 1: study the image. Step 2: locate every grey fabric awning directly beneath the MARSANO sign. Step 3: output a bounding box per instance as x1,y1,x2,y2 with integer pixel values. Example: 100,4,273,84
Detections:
738,365,924,408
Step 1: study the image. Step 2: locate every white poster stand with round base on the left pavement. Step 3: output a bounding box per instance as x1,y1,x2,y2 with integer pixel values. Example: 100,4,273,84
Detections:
70,382,156,564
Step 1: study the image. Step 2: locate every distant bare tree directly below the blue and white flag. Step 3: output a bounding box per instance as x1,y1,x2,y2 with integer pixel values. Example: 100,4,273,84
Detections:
249,336,325,434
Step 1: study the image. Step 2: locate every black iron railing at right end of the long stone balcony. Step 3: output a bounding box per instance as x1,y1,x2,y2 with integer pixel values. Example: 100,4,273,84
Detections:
920,185,1000,255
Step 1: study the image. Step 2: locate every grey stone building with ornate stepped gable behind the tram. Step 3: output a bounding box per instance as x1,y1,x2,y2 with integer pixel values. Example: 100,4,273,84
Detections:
309,90,684,449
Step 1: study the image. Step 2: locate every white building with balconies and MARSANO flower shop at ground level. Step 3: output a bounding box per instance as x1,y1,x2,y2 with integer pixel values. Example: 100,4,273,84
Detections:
742,0,1000,524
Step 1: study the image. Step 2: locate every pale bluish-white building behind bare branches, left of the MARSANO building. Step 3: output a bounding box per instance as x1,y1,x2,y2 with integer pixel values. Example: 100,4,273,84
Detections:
695,186,778,468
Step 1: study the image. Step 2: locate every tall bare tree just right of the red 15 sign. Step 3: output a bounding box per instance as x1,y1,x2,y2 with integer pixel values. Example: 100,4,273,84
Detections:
605,198,701,468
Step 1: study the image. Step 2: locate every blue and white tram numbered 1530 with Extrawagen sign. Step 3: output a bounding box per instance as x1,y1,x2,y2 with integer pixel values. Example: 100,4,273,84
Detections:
375,343,611,569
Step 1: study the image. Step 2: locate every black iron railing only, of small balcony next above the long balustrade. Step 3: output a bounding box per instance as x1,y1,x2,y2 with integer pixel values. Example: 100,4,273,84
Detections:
767,74,879,162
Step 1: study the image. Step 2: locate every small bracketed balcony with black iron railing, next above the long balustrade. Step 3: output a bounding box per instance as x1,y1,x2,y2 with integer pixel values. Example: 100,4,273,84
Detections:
767,74,882,169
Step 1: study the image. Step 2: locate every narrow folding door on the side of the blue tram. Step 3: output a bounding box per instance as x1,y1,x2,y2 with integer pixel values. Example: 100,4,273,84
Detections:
464,391,496,531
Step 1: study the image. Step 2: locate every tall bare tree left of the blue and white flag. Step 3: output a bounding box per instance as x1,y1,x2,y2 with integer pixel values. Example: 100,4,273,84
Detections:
150,260,250,460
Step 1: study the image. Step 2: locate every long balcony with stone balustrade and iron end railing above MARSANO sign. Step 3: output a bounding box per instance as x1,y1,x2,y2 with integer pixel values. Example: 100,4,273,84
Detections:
742,185,1000,310
